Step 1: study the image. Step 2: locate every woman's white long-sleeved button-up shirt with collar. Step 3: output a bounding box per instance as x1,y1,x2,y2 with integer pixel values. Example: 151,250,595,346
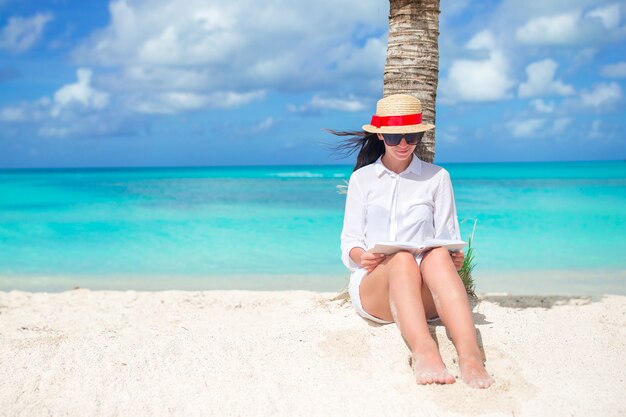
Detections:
341,155,461,272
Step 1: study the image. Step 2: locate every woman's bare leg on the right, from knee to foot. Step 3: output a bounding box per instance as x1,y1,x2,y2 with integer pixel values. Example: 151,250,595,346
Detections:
420,248,493,388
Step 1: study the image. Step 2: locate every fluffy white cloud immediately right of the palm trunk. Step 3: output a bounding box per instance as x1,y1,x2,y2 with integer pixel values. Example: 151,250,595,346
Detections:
440,30,513,102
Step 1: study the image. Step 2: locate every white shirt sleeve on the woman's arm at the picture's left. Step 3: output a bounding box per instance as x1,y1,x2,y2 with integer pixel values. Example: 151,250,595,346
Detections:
341,171,366,272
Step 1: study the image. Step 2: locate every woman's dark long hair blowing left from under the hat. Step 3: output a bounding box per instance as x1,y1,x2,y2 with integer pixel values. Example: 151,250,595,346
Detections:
325,129,385,172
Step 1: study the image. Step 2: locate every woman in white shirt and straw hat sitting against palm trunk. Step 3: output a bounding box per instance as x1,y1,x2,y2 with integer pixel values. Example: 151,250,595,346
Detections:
333,94,493,388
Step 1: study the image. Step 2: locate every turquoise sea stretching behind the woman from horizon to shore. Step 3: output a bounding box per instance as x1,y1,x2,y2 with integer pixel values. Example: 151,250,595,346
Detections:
0,161,626,294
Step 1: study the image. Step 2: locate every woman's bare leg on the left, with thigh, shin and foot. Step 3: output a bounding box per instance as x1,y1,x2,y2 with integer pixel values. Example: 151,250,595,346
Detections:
360,252,455,384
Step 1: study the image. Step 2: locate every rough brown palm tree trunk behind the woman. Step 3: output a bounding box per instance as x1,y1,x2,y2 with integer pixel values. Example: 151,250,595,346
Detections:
383,0,439,163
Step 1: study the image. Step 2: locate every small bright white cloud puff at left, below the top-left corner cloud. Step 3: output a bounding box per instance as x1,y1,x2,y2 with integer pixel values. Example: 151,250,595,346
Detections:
51,68,109,117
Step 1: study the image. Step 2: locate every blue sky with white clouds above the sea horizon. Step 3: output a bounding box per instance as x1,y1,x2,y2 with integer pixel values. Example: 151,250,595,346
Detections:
0,0,626,168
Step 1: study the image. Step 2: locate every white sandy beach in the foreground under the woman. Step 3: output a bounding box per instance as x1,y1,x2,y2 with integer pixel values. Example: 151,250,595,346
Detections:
0,290,626,417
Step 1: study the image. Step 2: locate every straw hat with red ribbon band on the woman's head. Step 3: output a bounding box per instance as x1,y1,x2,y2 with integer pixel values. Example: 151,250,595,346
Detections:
363,94,435,133
